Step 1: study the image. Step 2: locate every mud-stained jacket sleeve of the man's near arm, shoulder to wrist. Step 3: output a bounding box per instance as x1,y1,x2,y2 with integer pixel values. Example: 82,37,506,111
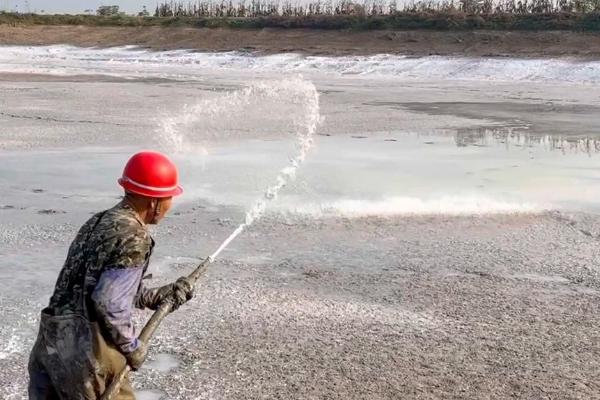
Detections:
91,231,150,354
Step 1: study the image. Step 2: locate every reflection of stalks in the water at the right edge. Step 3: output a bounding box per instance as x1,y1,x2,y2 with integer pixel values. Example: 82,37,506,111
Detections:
454,127,600,156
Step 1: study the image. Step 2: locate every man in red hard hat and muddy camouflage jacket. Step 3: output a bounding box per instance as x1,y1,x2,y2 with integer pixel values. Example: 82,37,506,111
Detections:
29,151,193,400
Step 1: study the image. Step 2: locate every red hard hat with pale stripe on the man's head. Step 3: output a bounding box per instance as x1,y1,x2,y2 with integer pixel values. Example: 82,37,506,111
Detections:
119,151,183,197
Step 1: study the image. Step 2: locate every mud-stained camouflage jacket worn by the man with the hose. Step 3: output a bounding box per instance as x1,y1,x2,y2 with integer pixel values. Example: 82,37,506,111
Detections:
48,202,154,353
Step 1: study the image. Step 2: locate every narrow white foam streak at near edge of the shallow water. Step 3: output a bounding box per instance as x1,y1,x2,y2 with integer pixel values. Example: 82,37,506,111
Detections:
288,196,546,218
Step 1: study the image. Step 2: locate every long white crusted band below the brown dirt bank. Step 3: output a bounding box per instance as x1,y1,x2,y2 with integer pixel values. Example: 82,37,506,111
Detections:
0,45,600,84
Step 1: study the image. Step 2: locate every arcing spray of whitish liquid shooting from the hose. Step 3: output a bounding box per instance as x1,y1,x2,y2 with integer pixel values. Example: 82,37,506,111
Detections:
160,77,321,261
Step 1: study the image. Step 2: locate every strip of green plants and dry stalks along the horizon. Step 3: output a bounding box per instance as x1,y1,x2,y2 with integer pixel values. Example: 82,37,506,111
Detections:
0,0,600,31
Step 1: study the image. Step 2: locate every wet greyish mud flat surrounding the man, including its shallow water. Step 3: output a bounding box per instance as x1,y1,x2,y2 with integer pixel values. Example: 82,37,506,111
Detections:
0,48,600,400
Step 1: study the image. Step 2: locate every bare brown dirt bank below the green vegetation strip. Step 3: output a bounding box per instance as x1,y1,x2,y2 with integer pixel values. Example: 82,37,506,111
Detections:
0,25,600,59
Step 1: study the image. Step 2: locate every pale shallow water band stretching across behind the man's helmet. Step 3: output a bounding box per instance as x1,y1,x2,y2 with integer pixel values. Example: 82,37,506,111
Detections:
0,130,600,222
